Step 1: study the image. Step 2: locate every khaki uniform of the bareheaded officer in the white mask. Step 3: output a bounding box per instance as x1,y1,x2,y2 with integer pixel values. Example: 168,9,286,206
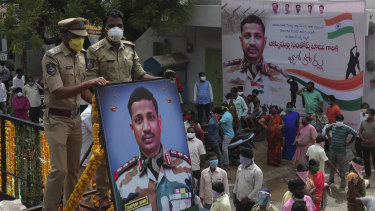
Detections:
86,38,146,199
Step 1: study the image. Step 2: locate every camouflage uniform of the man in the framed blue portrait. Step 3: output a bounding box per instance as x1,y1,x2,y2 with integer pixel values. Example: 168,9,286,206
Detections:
113,148,195,211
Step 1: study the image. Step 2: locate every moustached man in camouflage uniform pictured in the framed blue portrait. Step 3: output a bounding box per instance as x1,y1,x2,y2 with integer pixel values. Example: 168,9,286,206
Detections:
113,87,194,211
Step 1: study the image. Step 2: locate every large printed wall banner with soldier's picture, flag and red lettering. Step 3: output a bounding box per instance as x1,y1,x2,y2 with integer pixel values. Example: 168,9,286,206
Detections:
222,0,365,127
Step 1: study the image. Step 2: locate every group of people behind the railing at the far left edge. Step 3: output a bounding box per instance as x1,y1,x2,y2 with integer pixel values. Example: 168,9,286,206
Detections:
0,61,43,124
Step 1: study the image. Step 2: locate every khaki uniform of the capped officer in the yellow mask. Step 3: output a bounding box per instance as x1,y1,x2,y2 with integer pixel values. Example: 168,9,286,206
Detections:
42,43,85,211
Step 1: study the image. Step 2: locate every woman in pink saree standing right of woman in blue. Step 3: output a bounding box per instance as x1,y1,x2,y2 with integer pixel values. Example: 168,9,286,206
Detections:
292,117,318,165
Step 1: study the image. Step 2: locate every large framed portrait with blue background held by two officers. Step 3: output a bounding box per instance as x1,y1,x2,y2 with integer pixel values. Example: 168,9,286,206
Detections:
97,79,195,211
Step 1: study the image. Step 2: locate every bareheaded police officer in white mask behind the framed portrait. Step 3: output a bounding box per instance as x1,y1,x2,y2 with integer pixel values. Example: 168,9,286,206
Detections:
86,10,173,208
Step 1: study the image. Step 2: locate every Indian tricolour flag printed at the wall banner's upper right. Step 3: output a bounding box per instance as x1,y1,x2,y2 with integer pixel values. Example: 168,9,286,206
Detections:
324,13,354,39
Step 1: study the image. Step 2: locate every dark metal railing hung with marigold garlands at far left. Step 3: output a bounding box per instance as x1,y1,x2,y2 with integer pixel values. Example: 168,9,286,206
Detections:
0,114,44,206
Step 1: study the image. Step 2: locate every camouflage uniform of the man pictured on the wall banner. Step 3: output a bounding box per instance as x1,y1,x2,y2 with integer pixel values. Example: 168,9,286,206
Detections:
223,59,285,95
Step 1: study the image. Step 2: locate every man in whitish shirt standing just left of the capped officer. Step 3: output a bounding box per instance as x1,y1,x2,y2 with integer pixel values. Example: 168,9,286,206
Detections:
23,76,42,123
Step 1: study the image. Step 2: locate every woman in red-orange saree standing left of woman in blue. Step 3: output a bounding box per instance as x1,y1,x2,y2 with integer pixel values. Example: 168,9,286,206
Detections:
259,106,284,166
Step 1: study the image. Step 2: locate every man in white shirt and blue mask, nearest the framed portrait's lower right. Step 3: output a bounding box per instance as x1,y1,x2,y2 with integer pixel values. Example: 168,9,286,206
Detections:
199,152,229,209
